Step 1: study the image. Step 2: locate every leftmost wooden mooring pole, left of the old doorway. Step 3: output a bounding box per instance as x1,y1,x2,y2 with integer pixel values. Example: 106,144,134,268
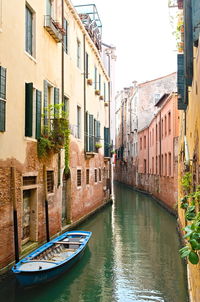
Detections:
10,167,19,263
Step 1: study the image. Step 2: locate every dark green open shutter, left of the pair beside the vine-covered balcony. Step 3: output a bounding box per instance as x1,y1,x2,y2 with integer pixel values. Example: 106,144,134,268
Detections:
25,83,33,137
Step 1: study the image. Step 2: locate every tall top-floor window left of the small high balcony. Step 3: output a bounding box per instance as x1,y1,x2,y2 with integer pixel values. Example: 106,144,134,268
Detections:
25,6,34,56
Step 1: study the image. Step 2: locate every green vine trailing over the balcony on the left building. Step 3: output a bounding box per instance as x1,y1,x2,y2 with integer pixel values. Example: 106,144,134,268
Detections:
37,104,70,174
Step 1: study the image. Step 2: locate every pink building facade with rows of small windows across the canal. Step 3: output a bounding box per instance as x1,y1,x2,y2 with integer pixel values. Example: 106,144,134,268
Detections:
136,93,179,208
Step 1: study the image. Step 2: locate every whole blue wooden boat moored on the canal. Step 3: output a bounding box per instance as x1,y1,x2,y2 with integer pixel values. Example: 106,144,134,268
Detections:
12,231,92,287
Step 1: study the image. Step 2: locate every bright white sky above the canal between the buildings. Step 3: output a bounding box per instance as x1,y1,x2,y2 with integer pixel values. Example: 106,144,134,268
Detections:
71,0,176,90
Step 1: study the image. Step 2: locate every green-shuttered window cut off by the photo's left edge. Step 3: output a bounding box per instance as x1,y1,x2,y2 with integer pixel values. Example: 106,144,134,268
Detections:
0,66,6,132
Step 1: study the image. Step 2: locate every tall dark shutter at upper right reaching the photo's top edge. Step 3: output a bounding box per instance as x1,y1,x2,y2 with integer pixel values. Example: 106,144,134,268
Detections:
184,0,193,86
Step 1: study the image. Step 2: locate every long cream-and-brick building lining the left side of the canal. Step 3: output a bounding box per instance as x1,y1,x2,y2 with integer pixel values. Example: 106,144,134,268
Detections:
0,0,110,271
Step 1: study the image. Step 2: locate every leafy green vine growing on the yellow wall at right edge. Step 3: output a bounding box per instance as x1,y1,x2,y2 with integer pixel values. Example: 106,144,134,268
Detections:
179,172,200,264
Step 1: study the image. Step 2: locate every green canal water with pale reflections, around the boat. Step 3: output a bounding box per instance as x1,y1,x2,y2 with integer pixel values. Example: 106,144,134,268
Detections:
0,184,188,302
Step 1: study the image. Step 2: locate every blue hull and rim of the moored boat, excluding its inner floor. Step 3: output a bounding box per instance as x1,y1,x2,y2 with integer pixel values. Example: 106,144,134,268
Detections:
12,231,91,287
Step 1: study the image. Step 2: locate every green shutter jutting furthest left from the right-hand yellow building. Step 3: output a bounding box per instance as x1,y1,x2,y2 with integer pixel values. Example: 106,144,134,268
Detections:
177,54,187,110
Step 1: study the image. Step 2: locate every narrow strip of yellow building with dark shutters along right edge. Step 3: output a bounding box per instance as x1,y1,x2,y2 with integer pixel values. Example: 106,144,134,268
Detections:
178,1,200,302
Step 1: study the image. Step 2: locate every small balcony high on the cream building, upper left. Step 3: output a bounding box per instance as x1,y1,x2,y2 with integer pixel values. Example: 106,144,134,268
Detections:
44,15,63,43
